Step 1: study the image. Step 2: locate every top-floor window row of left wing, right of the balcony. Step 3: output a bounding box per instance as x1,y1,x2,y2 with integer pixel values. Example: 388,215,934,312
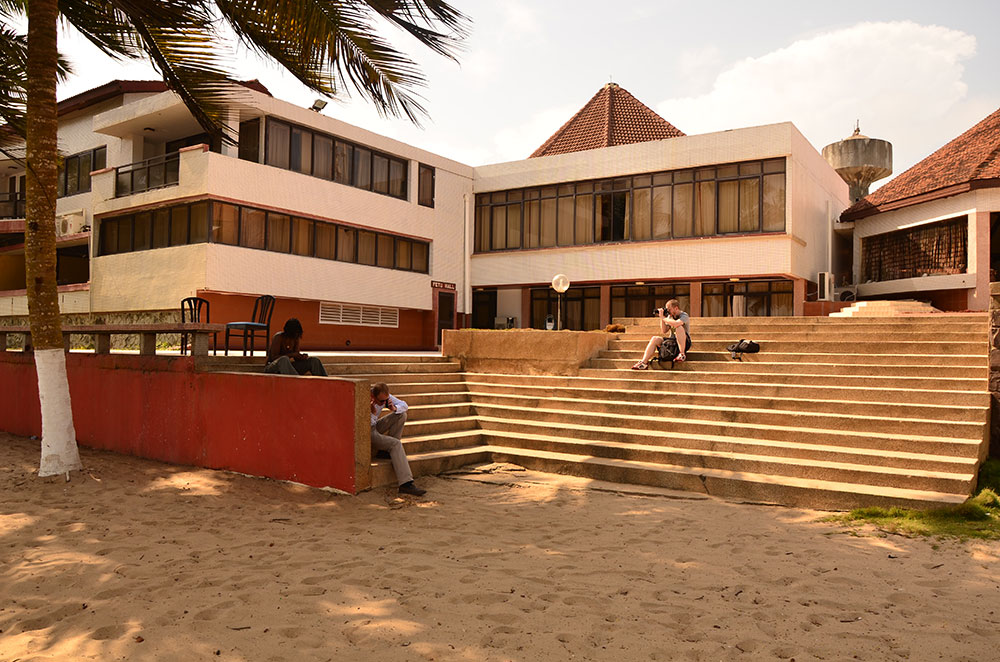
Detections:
254,117,434,207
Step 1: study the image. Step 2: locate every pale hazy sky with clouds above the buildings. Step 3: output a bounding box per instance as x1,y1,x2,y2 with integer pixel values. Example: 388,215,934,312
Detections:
50,0,1000,188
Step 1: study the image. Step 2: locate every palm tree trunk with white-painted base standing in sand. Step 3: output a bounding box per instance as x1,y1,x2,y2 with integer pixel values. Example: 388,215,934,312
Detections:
24,0,81,478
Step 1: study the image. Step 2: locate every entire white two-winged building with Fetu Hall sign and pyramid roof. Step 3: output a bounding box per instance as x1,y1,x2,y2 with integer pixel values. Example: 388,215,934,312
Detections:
0,81,849,349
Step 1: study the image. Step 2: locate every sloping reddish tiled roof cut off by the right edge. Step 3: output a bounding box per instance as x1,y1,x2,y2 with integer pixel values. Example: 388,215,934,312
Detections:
841,105,1000,221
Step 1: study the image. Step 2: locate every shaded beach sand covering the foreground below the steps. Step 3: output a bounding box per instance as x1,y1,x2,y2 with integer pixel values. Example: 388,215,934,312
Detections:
0,434,1000,662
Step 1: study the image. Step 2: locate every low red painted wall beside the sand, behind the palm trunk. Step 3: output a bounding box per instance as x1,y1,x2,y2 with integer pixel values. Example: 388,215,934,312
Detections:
0,352,356,493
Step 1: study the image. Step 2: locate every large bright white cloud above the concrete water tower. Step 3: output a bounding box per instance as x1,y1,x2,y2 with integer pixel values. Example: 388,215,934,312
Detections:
656,21,988,180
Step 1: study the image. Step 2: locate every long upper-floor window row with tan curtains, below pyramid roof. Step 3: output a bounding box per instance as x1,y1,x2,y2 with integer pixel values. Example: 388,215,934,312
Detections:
475,159,785,252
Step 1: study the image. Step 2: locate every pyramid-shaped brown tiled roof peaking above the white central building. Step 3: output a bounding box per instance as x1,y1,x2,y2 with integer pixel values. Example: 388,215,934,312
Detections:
531,83,684,158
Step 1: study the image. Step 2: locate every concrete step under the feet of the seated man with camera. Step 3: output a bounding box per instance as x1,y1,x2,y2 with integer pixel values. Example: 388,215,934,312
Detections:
589,354,987,380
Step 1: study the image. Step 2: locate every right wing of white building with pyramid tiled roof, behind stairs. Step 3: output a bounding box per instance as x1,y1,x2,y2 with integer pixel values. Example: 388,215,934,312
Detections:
472,83,849,329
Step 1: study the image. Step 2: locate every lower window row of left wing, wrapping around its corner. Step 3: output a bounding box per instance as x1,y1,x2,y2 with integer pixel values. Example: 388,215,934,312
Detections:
99,201,430,273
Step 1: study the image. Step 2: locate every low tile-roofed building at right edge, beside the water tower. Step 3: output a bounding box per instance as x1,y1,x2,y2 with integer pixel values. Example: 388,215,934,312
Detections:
840,110,1000,310
